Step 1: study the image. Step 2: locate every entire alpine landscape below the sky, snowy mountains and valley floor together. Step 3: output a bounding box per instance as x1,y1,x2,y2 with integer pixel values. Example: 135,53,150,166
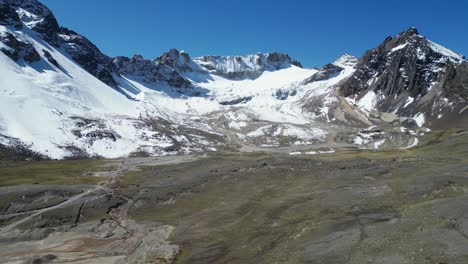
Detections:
0,0,468,264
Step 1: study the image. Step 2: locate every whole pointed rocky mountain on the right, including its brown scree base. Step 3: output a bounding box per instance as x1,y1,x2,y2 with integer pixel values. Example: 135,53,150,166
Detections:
341,28,467,126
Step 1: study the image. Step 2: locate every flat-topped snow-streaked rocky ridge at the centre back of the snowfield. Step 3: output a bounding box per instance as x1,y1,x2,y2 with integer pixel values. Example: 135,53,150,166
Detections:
194,52,302,79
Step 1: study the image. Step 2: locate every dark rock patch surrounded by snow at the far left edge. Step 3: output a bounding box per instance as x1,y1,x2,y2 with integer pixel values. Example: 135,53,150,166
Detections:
0,32,41,62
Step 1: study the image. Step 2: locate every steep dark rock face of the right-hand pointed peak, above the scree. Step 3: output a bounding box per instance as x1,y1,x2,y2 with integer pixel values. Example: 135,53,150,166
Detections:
341,28,463,115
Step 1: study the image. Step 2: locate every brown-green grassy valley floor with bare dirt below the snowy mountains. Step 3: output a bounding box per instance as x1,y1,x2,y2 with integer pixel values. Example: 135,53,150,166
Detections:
0,130,468,264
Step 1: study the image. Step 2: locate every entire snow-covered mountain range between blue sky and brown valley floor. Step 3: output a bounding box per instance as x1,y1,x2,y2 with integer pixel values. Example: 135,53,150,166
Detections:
0,0,468,158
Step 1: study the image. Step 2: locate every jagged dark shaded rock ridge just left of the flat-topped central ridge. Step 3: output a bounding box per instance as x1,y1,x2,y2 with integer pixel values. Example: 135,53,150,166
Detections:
113,49,196,88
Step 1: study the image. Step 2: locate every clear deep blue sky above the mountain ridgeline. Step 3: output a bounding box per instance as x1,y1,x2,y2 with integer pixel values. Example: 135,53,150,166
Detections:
40,0,468,67
